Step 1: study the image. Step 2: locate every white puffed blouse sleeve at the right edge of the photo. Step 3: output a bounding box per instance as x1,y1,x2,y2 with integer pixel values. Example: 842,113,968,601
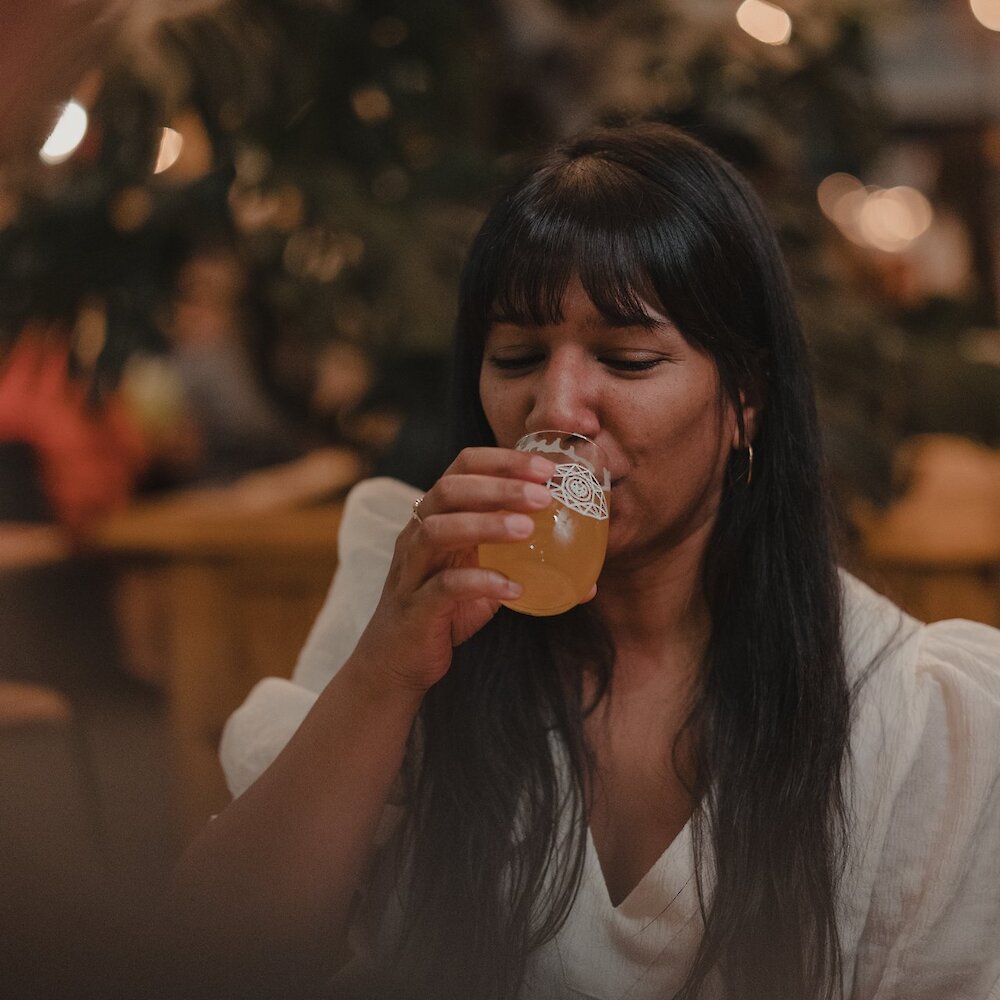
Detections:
852,621,1000,1000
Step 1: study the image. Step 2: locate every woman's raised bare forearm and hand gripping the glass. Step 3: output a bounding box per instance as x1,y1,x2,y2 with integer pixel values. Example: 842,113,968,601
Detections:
170,458,555,996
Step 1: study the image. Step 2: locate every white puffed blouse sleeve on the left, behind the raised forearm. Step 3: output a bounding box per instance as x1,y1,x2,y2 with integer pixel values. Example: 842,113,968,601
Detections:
219,478,420,796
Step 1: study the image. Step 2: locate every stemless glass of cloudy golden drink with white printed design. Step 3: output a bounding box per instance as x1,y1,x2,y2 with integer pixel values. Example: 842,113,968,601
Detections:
479,430,611,616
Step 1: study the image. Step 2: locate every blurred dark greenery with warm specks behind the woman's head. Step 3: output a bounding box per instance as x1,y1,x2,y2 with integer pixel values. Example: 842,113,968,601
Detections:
0,0,998,501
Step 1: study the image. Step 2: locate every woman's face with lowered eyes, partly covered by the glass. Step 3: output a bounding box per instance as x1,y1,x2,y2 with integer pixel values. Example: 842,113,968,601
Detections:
479,279,752,562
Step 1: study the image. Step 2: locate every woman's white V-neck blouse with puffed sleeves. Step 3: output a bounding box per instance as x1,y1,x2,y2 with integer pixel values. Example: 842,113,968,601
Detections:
221,479,1000,1000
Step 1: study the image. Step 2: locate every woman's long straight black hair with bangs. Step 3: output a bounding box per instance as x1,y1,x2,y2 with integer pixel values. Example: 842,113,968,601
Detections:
401,124,849,1000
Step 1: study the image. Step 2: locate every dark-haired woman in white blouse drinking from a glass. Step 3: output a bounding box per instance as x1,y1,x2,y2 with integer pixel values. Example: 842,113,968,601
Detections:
179,125,1000,1000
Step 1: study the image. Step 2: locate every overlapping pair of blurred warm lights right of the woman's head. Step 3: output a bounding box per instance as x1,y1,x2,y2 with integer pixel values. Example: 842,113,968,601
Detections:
816,173,934,253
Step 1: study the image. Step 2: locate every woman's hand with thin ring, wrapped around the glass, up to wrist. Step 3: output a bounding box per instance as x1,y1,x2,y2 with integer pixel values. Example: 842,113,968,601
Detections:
345,448,555,692
